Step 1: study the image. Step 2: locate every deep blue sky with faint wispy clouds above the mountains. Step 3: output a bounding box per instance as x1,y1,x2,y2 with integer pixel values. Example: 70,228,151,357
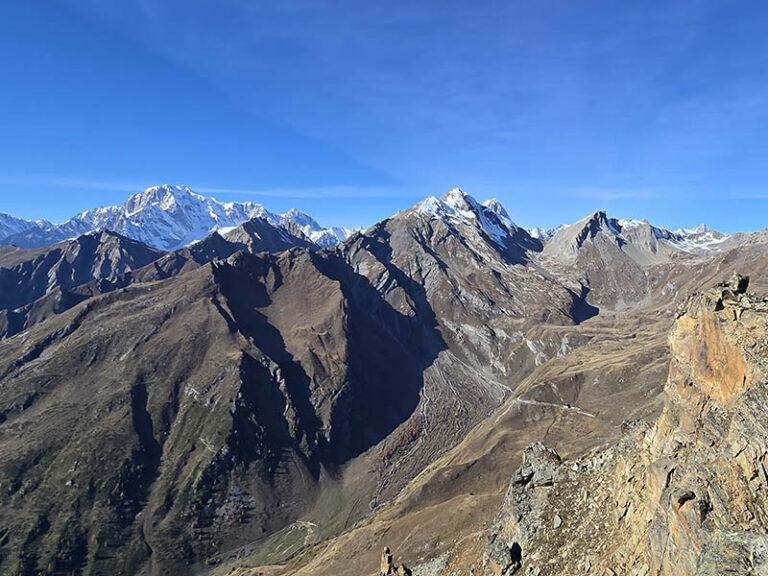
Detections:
0,0,768,231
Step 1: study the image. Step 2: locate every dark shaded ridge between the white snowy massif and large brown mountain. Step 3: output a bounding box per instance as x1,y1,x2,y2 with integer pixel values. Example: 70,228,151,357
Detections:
0,218,316,339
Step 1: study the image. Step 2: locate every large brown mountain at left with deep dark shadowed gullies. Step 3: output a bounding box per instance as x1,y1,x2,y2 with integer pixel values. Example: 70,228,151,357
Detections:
0,246,438,573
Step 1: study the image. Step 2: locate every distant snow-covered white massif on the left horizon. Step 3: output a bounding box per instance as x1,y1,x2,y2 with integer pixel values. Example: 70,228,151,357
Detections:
0,185,352,250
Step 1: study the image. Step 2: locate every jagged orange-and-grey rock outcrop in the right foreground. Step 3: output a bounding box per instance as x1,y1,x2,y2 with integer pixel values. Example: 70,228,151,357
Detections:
483,275,768,576
